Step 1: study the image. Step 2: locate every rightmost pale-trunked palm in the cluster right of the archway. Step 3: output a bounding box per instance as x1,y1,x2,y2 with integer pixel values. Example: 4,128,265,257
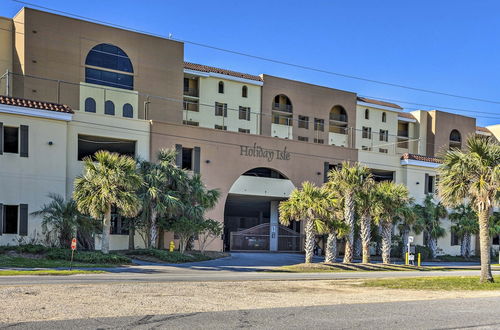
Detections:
375,181,411,264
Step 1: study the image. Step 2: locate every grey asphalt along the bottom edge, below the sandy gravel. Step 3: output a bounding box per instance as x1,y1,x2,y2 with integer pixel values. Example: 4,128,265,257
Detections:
0,298,500,329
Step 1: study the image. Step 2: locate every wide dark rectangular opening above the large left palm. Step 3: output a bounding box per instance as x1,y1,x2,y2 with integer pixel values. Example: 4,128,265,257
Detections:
78,135,135,160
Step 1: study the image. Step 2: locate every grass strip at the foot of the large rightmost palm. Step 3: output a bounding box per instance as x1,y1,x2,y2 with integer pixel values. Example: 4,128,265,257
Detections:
362,276,500,291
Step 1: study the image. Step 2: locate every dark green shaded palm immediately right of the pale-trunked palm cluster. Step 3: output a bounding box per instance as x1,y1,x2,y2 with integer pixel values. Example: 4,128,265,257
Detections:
415,194,448,259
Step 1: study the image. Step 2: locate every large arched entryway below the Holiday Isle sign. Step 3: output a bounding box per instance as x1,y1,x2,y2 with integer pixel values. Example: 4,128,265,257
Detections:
224,167,302,251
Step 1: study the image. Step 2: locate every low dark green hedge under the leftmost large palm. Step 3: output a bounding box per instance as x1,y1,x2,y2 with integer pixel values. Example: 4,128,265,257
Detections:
46,248,131,264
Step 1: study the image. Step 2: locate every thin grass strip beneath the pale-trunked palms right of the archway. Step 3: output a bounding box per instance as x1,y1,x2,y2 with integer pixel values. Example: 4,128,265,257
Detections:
267,263,447,273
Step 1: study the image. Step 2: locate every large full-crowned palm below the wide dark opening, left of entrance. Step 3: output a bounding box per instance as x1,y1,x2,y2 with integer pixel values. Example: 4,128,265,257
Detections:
73,150,142,253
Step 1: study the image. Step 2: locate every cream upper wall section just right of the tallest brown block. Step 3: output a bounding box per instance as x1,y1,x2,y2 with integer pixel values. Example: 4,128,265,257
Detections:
183,77,261,134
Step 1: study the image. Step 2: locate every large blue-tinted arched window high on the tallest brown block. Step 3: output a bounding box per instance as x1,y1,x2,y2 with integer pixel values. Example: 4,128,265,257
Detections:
85,44,134,90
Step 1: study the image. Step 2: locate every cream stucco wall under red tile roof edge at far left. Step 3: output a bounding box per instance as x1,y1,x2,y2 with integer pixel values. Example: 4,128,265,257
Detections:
0,113,67,245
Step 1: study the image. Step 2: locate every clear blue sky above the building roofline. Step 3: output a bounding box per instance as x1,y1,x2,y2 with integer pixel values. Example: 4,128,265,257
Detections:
0,0,500,126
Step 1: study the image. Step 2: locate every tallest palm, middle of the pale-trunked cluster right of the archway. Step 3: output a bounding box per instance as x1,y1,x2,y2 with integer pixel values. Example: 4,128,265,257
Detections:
327,162,372,263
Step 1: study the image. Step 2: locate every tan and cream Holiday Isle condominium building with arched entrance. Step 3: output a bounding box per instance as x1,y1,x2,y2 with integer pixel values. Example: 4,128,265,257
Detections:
0,8,500,254
